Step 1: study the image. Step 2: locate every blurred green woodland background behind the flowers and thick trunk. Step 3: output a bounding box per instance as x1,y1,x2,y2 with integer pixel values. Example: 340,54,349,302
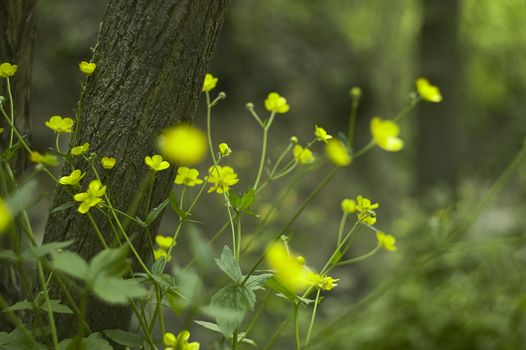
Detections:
32,0,526,349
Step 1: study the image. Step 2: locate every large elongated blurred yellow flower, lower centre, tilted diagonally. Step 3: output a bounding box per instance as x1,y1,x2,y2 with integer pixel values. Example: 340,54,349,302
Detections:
265,242,310,292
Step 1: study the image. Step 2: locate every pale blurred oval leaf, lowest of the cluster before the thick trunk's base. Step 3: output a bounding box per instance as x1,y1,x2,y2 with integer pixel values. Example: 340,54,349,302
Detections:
93,276,147,304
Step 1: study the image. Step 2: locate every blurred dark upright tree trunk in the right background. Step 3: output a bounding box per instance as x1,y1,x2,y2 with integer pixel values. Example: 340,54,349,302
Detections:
417,0,461,192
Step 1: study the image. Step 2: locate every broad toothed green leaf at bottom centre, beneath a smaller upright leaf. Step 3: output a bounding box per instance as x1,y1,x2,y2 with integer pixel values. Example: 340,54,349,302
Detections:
210,284,256,338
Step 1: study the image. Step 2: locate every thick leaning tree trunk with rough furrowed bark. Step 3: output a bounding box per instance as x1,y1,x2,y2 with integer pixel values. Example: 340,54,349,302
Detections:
44,0,229,337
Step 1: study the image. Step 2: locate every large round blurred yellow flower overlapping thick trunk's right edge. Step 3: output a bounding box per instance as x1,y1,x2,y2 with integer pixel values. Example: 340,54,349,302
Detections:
158,124,208,166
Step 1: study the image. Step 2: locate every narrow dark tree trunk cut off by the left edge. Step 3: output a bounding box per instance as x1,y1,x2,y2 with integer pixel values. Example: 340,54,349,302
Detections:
0,0,36,331
